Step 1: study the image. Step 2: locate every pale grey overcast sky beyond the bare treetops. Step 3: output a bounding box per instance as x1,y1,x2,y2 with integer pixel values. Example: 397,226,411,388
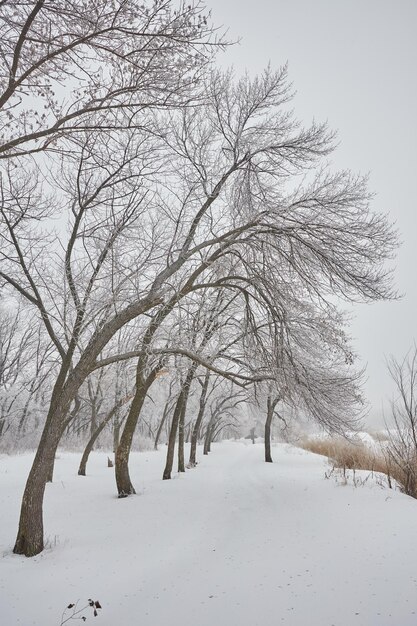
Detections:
207,0,417,425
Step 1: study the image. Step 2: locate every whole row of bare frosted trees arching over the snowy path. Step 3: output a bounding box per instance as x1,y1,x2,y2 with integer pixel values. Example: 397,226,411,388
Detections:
0,0,397,556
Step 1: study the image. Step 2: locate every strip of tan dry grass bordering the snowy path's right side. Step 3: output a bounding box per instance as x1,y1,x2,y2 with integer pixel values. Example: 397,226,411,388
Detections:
299,437,417,497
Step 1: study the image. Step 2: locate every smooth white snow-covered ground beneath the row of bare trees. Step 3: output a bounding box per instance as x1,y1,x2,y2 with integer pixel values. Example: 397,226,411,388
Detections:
0,442,417,626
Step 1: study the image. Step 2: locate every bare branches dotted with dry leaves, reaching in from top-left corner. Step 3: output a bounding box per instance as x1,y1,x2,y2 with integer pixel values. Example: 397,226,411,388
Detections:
0,0,220,159
